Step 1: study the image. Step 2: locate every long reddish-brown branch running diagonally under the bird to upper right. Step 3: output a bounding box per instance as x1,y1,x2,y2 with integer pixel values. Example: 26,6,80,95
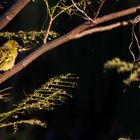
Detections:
0,6,140,83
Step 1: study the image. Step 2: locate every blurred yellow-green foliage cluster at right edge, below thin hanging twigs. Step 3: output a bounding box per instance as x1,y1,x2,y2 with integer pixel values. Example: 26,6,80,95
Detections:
104,58,140,84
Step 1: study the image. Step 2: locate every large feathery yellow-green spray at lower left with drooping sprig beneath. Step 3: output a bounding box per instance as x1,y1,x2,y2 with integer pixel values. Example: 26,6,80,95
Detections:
0,74,77,133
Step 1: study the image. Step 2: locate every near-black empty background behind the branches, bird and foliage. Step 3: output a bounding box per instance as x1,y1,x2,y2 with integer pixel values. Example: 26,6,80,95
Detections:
0,0,140,140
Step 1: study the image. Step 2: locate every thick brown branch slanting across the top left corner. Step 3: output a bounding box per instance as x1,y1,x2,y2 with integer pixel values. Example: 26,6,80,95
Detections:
0,0,30,30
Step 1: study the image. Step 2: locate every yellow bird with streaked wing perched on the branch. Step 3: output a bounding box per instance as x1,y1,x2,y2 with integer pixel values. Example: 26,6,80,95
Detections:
0,40,21,71
